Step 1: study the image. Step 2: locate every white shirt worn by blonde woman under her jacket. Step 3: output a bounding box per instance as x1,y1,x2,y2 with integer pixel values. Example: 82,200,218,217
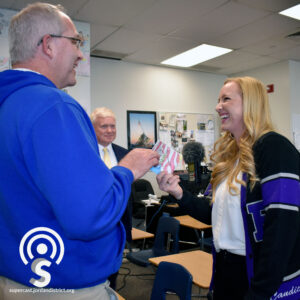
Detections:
212,172,246,255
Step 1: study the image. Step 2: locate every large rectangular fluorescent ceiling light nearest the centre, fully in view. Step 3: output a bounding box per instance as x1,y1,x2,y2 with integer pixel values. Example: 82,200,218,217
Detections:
161,44,232,67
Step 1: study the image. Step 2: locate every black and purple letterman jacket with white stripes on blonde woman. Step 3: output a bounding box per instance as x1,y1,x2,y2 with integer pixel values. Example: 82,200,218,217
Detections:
178,132,300,300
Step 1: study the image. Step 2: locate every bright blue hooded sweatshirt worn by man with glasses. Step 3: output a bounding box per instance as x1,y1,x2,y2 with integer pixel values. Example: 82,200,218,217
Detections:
0,70,133,289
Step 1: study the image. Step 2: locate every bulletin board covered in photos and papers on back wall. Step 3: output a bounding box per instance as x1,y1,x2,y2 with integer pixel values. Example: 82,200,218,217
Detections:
158,112,215,164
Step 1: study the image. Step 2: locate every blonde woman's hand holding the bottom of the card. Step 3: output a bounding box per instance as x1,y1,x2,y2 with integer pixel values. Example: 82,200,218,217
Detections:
156,171,183,200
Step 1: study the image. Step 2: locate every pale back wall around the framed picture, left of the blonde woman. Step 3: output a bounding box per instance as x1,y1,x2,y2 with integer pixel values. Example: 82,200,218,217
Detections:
91,58,226,196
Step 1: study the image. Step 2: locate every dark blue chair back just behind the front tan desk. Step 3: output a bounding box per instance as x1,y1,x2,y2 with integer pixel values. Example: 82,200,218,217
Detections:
153,215,180,256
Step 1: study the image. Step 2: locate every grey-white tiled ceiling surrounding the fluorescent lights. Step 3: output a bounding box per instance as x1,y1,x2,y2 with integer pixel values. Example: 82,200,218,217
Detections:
0,0,300,74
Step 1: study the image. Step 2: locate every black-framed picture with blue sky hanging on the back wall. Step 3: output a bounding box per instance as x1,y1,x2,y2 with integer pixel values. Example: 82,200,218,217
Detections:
127,110,157,150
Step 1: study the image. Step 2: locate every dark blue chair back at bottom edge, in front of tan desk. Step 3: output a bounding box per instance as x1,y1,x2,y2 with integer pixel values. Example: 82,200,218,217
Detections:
151,261,193,300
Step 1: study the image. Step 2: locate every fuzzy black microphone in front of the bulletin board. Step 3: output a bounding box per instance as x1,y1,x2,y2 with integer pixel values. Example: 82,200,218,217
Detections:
182,142,205,182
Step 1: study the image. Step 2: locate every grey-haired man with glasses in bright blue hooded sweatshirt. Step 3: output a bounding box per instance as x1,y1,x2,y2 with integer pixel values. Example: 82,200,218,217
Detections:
0,3,158,300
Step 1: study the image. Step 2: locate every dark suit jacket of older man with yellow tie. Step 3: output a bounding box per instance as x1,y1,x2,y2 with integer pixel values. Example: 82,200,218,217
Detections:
111,143,132,242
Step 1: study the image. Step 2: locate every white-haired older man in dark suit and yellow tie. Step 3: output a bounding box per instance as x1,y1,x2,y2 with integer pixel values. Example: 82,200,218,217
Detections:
90,107,132,289
